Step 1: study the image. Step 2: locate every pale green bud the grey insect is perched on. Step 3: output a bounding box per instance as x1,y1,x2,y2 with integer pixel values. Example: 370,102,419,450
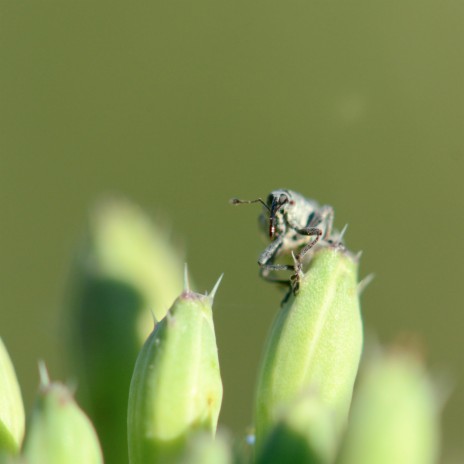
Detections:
255,247,363,449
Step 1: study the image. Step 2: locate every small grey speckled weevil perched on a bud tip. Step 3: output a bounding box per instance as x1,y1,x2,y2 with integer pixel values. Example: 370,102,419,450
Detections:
230,189,334,294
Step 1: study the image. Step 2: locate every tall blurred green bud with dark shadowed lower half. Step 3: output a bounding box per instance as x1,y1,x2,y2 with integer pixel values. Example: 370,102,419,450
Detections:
71,200,183,464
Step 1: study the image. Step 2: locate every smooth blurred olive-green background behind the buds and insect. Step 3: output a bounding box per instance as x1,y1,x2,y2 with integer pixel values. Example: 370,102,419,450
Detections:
0,0,464,457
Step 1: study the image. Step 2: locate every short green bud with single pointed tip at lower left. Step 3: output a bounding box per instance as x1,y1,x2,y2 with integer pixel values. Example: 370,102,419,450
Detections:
23,368,103,464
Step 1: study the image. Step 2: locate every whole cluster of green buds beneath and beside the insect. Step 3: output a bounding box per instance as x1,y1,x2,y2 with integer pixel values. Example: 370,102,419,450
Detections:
0,201,439,464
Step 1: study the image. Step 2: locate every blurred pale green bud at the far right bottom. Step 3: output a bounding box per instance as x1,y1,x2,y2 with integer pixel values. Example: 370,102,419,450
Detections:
337,350,440,464
